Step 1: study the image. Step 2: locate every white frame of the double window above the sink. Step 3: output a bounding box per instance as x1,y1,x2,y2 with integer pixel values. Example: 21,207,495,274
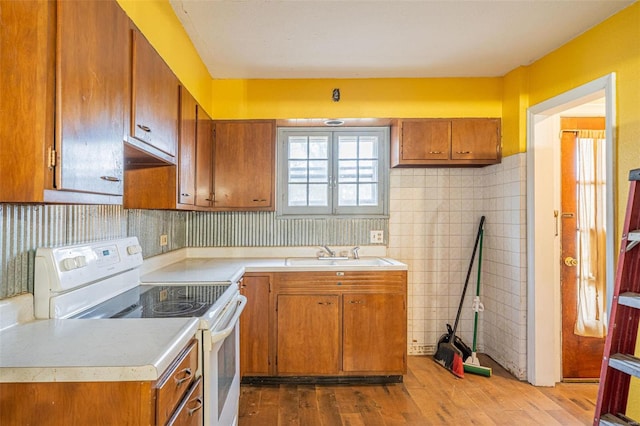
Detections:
276,127,390,218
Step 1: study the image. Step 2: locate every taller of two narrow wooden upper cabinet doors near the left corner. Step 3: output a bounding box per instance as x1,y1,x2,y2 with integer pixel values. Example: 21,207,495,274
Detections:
178,86,196,205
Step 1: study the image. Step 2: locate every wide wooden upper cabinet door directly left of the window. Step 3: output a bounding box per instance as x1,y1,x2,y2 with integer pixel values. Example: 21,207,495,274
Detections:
214,121,275,210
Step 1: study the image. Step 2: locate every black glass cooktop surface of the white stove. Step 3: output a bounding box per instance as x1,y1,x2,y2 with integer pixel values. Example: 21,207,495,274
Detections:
74,284,229,318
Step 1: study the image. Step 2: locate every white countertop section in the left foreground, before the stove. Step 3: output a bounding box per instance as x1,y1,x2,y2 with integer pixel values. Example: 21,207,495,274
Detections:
0,318,198,383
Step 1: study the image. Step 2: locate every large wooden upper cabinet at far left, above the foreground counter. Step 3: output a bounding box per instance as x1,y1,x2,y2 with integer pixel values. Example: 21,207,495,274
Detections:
0,0,130,204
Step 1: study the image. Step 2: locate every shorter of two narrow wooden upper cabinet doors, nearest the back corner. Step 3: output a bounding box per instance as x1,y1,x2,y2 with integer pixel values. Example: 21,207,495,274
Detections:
196,107,213,207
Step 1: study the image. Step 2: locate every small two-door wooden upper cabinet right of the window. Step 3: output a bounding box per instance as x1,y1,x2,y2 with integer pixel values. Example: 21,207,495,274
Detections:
391,118,502,167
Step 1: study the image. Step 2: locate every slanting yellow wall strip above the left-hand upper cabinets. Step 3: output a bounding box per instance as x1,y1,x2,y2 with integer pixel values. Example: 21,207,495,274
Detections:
117,0,212,114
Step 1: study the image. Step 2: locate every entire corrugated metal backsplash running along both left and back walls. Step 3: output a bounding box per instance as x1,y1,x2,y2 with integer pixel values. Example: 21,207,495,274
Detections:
0,204,388,299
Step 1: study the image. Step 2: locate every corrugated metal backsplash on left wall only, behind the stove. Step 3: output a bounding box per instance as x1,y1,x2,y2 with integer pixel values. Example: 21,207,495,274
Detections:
0,204,186,299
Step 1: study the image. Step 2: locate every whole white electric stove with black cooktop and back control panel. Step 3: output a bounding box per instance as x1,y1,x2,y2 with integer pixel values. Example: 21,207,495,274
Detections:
34,237,246,426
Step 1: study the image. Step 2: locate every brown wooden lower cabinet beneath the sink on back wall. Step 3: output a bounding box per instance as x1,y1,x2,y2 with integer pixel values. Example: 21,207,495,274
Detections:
240,271,407,382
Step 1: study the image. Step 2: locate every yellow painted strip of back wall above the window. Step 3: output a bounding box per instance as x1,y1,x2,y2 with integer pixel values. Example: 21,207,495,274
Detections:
212,78,502,119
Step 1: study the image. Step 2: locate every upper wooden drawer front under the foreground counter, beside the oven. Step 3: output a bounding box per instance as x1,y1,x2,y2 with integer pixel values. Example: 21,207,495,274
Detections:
156,340,198,425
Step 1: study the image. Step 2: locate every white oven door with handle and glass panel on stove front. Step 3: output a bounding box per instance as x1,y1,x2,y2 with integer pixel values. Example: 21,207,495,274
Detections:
202,295,247,426
